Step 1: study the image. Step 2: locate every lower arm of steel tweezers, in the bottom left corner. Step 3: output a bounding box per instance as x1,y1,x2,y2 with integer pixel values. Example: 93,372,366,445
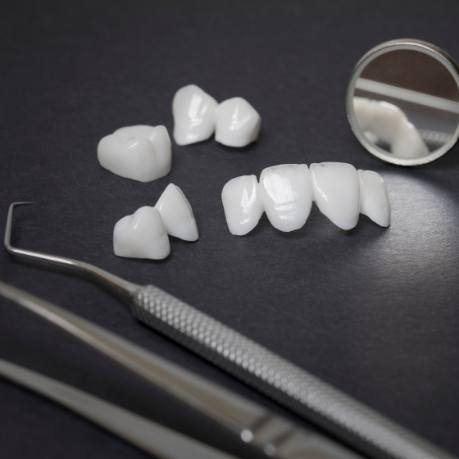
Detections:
0,359,239,459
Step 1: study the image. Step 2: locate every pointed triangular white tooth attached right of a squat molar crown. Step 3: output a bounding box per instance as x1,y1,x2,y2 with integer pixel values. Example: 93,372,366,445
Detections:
155,183,199,241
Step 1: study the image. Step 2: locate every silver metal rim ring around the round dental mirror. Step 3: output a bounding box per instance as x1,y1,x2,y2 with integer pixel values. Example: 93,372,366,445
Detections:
346,38,459,166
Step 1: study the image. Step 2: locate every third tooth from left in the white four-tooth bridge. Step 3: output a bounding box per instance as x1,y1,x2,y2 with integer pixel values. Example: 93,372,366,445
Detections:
309,162,360,230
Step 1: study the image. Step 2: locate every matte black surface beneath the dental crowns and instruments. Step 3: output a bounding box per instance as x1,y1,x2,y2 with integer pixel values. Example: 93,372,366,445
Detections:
0,0,459,459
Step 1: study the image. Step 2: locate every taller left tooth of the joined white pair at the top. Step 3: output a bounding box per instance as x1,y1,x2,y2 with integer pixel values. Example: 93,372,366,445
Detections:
172,84,217,145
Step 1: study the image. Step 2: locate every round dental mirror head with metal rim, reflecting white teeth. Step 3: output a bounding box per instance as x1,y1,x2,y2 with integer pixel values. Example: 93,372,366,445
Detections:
346,39,459,166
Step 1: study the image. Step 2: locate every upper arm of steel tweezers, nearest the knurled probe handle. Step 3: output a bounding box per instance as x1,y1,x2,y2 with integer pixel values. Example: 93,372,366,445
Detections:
0,282,358,459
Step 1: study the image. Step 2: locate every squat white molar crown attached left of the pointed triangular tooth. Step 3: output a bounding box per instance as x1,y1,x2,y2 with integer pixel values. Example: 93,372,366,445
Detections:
113,206,170,260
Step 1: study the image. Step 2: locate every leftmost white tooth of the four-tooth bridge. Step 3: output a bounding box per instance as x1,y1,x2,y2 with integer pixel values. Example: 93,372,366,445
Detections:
222,175,263,236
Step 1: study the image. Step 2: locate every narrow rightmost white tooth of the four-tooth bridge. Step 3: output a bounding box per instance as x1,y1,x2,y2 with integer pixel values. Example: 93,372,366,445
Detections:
358,170,390,227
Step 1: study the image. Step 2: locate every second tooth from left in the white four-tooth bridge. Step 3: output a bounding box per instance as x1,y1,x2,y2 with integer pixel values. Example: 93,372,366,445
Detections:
259,164,313,232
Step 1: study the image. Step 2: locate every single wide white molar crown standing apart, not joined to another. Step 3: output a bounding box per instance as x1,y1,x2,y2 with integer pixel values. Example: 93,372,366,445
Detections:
97,125,172,182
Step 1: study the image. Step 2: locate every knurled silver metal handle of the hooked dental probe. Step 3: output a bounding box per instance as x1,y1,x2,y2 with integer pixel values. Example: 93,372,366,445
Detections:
132,286,453,459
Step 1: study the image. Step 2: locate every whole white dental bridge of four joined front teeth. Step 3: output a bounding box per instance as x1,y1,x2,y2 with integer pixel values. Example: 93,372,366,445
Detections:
222,162,390,236
